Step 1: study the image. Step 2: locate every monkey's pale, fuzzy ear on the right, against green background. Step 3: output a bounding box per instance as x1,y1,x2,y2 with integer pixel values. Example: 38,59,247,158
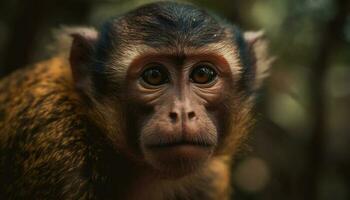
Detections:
244,31,275,90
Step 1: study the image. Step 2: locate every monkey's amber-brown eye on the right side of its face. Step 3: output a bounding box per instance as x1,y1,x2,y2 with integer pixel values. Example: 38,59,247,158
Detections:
190,63,217,84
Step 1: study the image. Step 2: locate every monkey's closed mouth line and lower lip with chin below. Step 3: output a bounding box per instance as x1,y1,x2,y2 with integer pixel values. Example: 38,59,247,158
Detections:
143,137,216,176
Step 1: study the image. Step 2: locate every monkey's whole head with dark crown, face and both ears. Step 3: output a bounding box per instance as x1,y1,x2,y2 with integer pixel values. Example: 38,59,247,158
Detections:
70,2,270,176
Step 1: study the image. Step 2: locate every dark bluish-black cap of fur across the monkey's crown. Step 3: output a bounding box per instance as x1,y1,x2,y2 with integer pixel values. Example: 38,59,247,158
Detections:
93,2,240,57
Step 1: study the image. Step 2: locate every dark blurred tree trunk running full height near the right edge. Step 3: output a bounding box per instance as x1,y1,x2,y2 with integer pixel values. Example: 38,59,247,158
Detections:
303,0,350,200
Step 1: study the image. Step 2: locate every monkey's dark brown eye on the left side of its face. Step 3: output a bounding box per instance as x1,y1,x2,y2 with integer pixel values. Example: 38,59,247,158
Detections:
141,65,169,86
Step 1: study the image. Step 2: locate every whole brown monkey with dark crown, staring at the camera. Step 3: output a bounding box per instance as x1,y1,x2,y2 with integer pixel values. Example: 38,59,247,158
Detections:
0,2,271,200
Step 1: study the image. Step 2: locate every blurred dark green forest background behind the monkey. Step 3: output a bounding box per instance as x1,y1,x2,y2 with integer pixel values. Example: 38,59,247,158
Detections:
0,0,350,200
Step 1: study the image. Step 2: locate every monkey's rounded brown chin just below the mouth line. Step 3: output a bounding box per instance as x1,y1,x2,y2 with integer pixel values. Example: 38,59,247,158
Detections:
144,144,214,179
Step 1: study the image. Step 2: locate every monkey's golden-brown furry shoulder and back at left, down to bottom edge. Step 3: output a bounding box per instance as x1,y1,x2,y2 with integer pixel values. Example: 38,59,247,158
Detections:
0,58,94,199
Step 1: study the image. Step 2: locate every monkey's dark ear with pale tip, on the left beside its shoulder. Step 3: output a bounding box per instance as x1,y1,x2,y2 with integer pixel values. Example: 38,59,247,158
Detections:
69,28,98,90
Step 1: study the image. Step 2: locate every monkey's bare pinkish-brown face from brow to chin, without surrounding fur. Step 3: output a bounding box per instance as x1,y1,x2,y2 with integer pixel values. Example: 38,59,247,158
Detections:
126,55,235,177
